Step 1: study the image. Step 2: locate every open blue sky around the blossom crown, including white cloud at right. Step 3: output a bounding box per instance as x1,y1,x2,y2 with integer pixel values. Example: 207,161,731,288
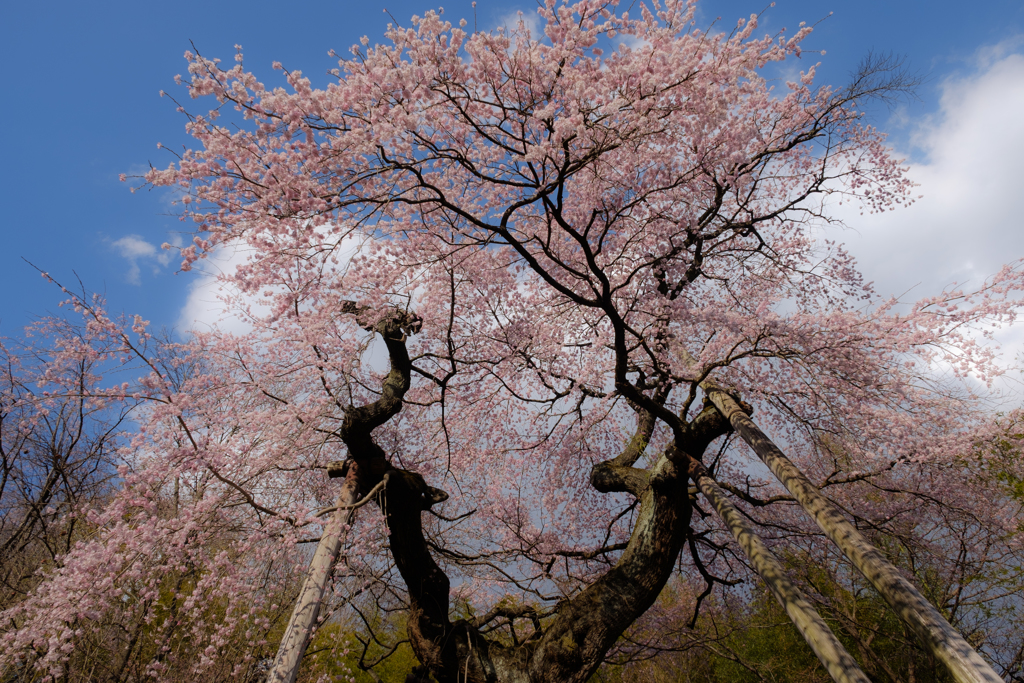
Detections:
0,0,1024,336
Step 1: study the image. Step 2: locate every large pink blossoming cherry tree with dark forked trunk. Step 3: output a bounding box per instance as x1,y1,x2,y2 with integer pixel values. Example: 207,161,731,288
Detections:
3,0,1024,681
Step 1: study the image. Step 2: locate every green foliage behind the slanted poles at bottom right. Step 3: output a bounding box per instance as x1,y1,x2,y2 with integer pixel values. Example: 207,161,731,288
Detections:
592,555,966,683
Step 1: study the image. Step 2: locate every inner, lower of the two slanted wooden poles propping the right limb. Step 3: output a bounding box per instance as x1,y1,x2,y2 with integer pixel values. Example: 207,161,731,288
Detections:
690,460,870,683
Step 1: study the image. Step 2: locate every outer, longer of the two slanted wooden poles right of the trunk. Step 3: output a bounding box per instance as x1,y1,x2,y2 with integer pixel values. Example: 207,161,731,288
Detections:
701,382,1002,683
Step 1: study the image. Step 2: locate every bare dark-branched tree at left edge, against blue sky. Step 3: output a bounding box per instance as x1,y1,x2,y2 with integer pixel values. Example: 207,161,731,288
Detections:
0,309,132,607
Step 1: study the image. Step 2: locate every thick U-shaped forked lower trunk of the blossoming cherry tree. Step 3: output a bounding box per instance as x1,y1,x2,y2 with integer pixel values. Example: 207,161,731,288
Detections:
386,397,729,683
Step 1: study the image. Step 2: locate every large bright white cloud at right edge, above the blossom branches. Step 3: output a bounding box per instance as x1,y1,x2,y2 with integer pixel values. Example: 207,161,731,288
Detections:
840,47,1024,299
